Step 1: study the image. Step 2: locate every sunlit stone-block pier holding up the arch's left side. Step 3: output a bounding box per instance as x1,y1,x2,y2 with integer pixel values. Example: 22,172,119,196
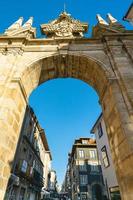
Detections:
0,80,26,200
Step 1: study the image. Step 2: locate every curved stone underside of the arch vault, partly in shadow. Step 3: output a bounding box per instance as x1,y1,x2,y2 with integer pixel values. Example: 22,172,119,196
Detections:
19,54,113,100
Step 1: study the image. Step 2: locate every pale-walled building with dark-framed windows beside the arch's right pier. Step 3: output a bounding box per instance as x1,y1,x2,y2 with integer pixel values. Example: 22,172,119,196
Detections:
91,114,121,200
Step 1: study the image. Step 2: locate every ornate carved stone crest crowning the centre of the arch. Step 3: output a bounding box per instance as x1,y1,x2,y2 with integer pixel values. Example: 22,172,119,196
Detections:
41,12,88,38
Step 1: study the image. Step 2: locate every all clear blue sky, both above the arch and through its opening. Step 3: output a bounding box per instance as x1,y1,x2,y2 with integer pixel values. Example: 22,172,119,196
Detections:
0,0,132,186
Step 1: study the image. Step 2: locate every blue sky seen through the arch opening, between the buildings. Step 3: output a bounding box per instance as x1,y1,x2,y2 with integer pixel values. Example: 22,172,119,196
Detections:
29,78,101,184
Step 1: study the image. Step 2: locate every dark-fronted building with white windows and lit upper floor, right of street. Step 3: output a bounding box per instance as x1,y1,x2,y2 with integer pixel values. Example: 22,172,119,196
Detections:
66,138,104,200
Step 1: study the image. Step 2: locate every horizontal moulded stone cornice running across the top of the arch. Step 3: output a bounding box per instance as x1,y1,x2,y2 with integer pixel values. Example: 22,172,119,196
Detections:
0,31,133,55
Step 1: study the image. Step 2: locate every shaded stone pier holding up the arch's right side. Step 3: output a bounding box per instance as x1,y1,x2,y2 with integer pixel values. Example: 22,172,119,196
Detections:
102,79,133,200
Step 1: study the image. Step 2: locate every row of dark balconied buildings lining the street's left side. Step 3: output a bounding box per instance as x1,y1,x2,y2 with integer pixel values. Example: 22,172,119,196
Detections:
5,106,52,200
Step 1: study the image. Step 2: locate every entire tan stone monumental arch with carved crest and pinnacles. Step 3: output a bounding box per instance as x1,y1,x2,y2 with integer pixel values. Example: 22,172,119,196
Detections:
0,11,133,200
